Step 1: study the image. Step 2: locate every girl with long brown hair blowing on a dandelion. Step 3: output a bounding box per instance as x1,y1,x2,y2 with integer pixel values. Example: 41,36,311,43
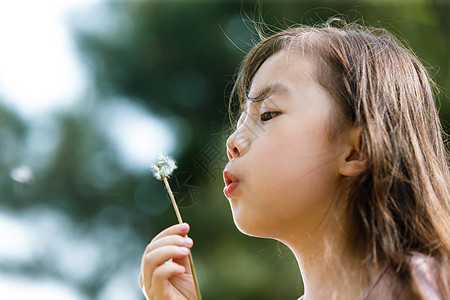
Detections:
140,20,450,300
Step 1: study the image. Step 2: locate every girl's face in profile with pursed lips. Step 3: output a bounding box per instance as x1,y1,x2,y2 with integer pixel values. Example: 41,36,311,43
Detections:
224,51,343,240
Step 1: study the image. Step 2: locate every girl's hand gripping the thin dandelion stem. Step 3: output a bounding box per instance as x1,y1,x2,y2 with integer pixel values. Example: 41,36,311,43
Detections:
139,224,197,300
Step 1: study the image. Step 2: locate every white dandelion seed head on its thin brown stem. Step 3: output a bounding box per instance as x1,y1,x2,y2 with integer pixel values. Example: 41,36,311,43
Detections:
153,154,202,300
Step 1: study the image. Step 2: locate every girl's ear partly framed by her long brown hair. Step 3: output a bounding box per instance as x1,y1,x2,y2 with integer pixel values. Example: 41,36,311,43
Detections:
339,127,367,176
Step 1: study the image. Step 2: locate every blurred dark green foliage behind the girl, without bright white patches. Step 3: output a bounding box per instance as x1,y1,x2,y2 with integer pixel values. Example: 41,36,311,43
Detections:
0,1,450,299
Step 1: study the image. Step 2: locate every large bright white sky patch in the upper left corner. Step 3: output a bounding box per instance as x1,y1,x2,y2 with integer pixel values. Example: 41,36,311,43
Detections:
0,0,89,117
